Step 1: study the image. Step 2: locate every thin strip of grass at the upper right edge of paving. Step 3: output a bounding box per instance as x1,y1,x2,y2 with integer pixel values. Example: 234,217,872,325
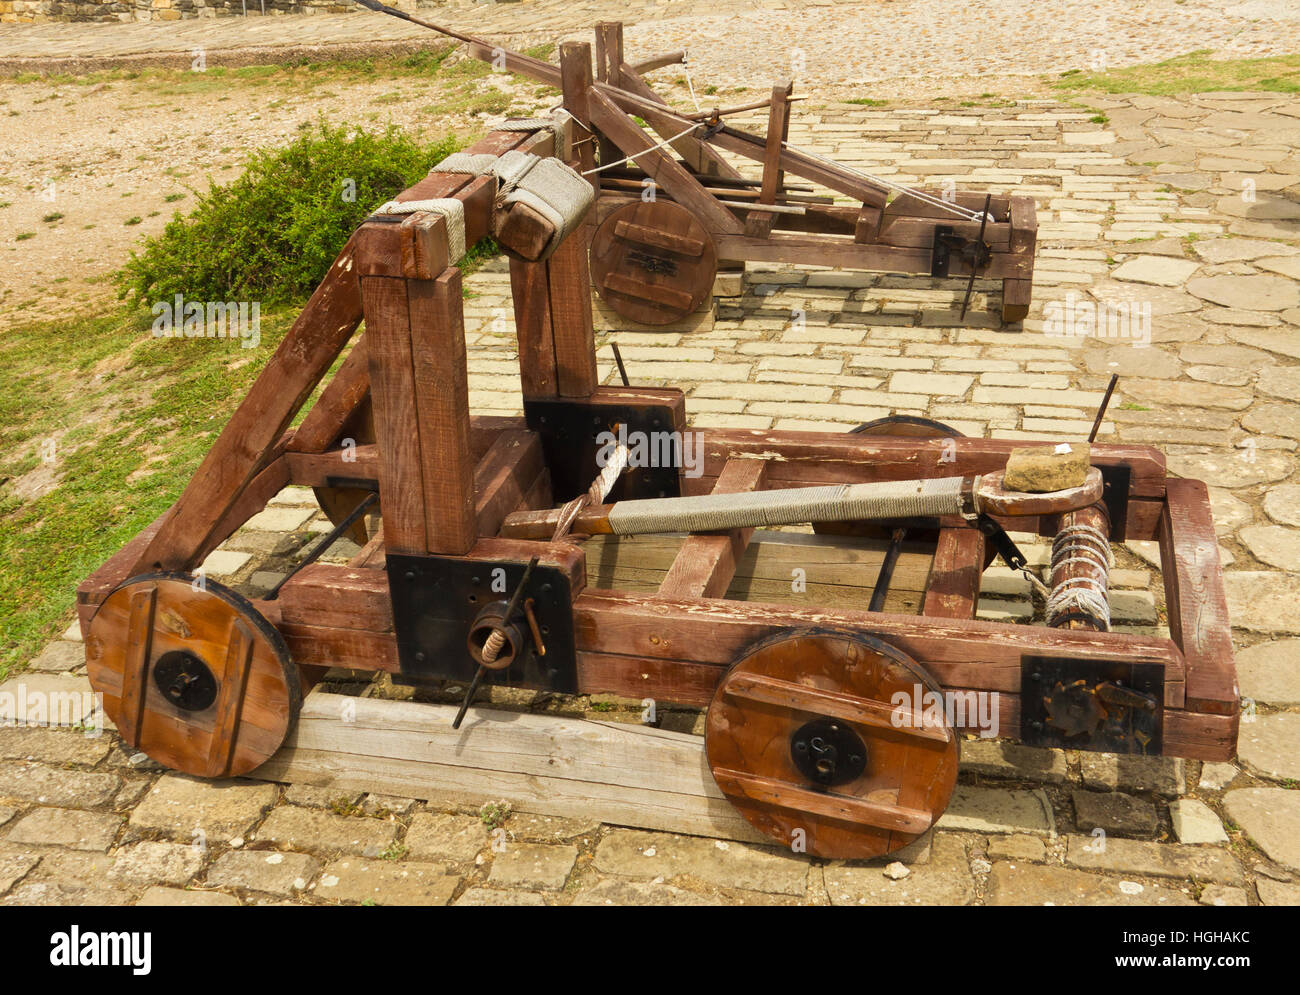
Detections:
1054,51,1300,96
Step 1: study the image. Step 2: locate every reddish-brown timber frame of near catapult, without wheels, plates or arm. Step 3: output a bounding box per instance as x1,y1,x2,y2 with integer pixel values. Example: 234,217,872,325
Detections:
78,114,1238,845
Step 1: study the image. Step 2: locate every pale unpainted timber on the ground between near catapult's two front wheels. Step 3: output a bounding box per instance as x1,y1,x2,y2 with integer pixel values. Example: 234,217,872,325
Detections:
252,692,770,843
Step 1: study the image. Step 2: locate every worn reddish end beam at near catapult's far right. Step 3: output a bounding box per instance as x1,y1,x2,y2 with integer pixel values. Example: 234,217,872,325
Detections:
1160,479,1240,721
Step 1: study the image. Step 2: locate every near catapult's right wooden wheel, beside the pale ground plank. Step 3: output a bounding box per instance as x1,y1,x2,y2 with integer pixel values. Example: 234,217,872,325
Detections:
705,630,958,860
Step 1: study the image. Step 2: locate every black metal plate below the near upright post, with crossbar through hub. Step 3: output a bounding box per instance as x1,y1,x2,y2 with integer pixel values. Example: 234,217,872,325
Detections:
387,553,577,695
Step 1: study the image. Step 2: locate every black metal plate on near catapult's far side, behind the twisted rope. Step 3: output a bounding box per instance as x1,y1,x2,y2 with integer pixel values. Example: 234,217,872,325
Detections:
524,398,683,502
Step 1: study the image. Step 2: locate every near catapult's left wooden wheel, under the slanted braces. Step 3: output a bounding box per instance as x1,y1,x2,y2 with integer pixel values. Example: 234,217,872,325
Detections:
86,574,303,778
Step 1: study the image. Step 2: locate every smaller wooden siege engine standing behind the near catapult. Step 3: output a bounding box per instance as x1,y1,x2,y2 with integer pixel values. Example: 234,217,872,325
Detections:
374,8,1039,325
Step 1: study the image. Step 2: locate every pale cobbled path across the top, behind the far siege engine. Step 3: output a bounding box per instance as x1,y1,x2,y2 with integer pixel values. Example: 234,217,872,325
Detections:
0,0,1300,85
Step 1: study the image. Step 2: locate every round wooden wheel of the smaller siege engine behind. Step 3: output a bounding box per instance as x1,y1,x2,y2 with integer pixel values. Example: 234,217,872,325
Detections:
590,200,718,325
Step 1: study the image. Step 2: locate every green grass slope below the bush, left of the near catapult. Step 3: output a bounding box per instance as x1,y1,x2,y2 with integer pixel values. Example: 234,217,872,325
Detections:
0,308,312,678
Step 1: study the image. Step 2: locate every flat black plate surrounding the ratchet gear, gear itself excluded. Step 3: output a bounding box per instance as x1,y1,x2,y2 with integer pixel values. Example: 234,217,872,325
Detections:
1021,656,1165,756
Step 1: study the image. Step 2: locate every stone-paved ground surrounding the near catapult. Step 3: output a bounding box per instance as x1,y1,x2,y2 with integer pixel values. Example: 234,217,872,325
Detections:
0,85,1300,904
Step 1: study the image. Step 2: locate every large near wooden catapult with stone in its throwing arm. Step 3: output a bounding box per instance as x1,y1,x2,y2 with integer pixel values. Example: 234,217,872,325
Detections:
78,27,1239,857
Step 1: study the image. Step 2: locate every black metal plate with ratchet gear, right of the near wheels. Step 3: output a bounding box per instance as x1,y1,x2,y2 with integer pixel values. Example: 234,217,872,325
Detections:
1021,656,1165,754
